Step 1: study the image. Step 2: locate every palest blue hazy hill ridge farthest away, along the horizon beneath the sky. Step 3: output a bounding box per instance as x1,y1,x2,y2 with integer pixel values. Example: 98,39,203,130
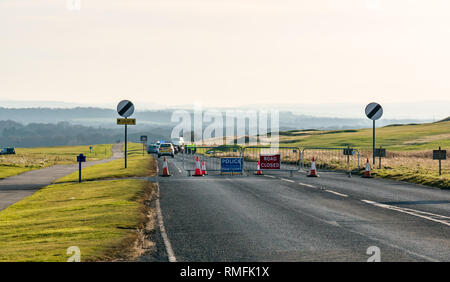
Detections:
0,107,426,130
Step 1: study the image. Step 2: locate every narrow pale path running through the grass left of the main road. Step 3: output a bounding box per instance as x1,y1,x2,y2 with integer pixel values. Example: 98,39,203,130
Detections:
0,144,123,210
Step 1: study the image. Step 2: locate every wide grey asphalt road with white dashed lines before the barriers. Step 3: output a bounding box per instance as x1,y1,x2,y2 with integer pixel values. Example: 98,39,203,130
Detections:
152,153,450,262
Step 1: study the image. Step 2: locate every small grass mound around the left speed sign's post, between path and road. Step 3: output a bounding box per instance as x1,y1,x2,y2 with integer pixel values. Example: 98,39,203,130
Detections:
55,152,156,183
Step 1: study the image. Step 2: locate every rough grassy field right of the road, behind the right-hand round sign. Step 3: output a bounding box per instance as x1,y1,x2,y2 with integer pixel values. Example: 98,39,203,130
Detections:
280,121,450,189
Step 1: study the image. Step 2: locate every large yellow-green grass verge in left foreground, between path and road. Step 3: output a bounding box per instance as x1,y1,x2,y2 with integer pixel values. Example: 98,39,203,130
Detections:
0,180,153,262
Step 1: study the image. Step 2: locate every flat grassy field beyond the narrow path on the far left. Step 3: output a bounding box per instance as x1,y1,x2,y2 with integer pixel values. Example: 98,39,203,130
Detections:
0,144,112,179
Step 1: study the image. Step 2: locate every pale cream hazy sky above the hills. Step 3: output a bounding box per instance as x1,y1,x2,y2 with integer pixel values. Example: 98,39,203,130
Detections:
0,0,450,109
